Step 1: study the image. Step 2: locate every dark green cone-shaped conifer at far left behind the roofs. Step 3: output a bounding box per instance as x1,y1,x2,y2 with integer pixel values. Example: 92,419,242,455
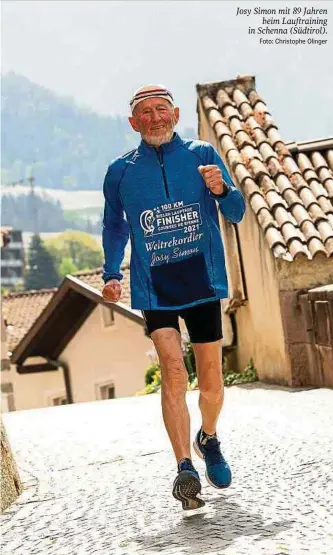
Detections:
24,234,60,290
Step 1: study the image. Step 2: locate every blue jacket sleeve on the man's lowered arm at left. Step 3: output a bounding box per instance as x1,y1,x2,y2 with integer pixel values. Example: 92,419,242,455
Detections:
102,163,129,283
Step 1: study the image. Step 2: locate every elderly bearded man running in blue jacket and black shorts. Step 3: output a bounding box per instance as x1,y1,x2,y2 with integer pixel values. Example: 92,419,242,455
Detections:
103,85,245,509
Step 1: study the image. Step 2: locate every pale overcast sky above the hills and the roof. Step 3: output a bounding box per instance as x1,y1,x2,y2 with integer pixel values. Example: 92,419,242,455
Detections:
2,0,333,140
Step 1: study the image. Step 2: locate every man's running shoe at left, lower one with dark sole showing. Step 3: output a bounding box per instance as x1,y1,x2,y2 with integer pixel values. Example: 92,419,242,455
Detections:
172,459,205,511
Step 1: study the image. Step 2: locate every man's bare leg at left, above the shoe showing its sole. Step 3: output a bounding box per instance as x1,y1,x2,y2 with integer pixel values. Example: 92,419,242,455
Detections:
151,328,191,462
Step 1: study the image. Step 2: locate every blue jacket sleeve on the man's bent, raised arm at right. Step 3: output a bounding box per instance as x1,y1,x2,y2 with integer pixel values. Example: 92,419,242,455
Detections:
207,145,245,227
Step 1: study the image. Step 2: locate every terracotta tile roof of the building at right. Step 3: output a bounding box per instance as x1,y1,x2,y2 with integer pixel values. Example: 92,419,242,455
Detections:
197,76,333,260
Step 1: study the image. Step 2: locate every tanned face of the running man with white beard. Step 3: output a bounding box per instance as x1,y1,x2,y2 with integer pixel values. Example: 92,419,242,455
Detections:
128,98,179,146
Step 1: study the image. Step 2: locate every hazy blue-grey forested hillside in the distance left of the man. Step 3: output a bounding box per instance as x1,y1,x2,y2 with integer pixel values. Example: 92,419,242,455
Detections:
1,73,138,191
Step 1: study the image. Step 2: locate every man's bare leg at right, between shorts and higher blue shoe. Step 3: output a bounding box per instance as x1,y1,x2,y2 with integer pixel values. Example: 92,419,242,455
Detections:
193,340,224,435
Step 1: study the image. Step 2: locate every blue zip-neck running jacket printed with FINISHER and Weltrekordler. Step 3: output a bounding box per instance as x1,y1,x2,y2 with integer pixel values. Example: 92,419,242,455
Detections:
102,133,245,310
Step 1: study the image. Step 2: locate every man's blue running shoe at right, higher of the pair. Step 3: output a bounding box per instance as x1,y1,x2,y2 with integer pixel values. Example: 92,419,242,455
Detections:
193,429,231,489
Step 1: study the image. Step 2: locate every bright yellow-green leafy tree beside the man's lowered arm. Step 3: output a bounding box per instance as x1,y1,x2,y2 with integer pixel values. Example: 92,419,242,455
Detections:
45,231,103,273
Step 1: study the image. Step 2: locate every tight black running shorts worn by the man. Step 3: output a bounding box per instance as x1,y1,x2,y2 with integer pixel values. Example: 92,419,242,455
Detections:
142,300,222,343
